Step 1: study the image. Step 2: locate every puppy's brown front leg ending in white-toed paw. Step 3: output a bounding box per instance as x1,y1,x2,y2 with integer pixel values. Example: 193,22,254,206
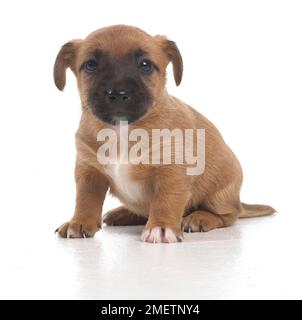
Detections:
142,170,189,243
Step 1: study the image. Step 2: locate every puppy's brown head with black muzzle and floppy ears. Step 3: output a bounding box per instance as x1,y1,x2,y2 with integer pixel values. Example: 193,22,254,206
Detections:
54,25,183,125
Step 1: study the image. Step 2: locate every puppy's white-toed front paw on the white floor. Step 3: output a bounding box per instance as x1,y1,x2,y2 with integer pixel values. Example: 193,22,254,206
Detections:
141,227,183,243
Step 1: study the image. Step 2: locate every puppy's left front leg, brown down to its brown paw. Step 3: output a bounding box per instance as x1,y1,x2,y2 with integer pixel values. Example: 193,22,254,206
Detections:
56,165,108,238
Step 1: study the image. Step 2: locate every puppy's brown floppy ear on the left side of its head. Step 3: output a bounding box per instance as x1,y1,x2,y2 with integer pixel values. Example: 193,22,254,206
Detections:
53,40,81,91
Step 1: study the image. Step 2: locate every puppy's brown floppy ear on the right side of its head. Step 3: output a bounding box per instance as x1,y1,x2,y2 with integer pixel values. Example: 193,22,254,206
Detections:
155,35,183,86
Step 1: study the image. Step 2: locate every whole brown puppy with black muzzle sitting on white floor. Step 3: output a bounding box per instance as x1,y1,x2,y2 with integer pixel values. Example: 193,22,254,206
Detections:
54,25,274,243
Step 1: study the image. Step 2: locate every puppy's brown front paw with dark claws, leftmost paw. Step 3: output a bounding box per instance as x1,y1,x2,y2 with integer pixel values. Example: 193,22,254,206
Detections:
55,220,101,239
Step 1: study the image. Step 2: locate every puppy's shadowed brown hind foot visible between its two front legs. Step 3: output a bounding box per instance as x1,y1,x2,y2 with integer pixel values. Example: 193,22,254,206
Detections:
103,206,147,226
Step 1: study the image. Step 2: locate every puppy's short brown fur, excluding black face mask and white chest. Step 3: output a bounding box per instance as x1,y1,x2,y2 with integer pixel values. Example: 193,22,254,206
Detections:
54,26,274,242
